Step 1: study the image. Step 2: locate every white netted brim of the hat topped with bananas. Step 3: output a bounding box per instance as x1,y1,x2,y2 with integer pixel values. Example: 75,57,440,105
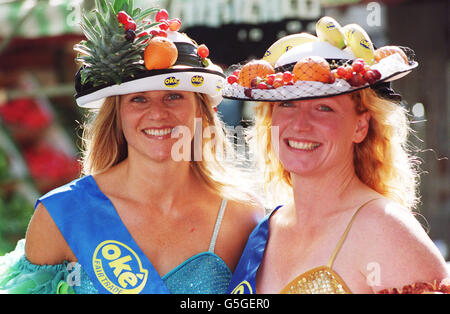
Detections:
222,54,418,102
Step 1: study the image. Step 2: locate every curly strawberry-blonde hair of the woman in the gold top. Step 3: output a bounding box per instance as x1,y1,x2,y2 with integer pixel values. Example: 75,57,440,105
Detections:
252,88,419,210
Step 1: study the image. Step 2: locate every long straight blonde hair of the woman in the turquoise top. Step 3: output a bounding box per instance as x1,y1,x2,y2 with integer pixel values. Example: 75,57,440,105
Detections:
82,93,256,202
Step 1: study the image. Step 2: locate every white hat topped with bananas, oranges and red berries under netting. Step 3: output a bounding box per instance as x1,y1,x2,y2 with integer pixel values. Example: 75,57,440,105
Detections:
222,16,418,101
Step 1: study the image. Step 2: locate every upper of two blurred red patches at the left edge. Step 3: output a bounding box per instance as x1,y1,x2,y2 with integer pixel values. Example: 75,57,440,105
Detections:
0,98,52,131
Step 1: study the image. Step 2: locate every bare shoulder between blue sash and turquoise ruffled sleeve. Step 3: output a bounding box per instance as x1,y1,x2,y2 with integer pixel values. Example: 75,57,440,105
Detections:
25,203,76,265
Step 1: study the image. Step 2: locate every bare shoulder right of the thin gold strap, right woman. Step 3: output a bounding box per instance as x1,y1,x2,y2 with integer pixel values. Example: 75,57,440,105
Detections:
351,198,449,291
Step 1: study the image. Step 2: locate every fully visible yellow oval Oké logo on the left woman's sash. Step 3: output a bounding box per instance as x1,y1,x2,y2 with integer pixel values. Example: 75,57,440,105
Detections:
92,240,148,294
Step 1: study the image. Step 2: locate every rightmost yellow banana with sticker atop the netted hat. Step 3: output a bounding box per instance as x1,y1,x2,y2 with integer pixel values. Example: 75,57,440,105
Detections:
342,24,374,64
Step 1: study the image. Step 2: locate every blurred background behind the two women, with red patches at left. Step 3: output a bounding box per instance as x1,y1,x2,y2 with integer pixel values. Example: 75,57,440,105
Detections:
0,0,450,268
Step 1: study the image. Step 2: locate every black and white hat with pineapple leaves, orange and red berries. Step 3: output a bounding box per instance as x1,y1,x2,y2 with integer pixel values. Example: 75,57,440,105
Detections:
74,0,225,108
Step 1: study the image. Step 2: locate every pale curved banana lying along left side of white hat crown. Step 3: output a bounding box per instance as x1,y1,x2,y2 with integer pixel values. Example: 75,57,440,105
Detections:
262,33,319,66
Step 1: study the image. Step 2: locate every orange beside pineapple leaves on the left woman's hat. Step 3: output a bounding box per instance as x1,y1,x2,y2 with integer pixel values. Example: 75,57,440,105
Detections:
144,36,178,70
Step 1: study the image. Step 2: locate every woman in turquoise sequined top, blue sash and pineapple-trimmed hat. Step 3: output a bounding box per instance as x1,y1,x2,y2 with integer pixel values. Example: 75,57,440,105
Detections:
0,1,263,294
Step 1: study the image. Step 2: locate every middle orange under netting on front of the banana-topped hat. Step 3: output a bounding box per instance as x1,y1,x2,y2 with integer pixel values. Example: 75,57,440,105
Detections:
292,56,331,83
